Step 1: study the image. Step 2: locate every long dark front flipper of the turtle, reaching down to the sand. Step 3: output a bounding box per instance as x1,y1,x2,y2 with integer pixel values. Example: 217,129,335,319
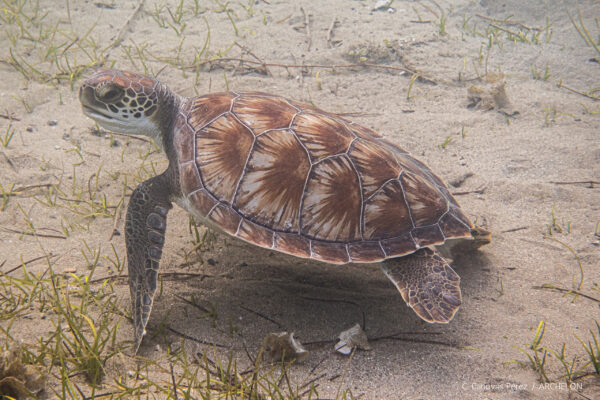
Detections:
125,174,172,354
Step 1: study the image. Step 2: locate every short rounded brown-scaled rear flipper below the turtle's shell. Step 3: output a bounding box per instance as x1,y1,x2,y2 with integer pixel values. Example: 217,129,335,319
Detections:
380,248,461,323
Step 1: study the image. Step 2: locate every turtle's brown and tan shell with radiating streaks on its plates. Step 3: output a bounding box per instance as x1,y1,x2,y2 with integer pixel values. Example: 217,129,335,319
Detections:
174,93,473,264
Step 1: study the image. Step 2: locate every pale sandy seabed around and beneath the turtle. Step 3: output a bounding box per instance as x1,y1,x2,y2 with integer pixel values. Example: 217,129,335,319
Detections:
0,0,600,399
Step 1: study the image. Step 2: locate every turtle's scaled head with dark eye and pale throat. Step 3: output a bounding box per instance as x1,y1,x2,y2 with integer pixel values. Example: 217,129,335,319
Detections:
79,69,179,148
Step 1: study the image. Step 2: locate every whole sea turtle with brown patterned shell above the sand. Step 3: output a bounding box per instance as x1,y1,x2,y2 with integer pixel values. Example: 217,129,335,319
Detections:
79,69,489,351
